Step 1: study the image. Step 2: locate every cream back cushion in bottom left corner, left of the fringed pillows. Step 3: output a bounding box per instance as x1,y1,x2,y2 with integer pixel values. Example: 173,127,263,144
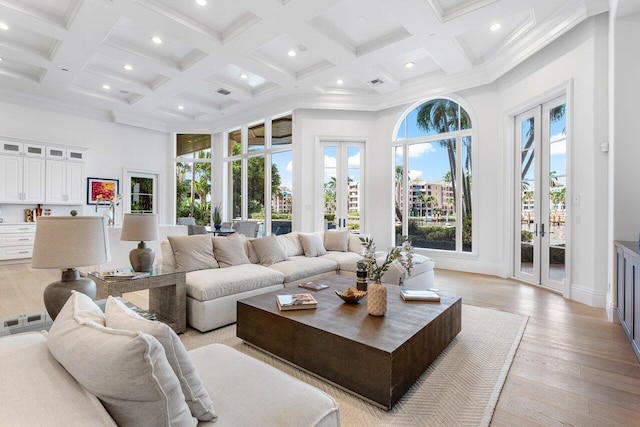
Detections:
0,332,116,427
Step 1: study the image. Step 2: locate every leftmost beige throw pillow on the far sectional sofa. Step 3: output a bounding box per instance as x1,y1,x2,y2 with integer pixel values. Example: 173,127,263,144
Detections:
167,234,218,271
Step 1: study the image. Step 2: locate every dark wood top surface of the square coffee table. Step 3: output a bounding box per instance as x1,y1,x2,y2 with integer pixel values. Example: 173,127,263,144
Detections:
238,275,460,353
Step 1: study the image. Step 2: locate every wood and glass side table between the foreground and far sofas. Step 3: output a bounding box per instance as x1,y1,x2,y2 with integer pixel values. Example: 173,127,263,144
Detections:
89,266,187,334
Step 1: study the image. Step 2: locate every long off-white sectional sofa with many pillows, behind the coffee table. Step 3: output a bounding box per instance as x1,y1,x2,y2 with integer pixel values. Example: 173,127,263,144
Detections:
161,231,434,332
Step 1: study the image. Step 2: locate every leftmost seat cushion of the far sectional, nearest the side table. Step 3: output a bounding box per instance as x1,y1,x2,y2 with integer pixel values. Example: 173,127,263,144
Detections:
187,261,286,301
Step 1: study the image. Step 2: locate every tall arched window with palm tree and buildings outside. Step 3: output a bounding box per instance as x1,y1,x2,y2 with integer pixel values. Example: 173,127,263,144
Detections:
394,99,473,252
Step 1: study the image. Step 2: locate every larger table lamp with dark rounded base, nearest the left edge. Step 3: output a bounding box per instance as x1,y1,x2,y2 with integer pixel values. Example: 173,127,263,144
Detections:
31,216,111,319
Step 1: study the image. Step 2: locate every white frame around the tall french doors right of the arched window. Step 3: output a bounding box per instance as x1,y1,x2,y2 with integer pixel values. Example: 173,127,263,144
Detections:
503,90,573,299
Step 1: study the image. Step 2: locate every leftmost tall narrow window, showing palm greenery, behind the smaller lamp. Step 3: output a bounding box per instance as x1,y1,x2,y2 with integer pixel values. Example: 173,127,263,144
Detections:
176,134,211,225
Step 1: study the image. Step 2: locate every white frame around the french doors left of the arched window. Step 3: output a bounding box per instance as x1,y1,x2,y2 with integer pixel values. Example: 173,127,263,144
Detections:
314,136,367,234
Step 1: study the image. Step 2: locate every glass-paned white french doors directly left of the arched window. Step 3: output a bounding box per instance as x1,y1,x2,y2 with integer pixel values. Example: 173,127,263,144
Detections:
320,141,365,233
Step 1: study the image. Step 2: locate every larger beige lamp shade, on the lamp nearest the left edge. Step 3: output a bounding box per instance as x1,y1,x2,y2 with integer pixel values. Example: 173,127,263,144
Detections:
31,216,111,268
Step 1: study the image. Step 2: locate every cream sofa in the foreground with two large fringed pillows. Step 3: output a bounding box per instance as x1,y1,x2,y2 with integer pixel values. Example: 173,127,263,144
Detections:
0,292,340,427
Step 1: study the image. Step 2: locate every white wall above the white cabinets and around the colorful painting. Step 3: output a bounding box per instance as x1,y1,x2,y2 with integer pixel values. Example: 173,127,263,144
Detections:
0,102,173,223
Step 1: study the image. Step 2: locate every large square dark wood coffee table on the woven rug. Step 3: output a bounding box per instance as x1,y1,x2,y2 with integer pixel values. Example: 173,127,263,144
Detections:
237,276,462,410
